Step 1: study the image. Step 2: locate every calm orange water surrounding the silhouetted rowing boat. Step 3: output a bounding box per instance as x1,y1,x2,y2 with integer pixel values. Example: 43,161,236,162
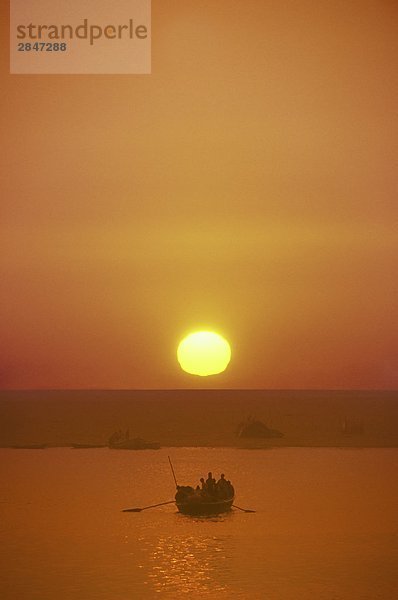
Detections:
0,448,398,600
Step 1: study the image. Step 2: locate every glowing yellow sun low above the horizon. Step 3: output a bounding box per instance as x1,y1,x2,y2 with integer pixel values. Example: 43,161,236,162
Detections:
177,331,231,377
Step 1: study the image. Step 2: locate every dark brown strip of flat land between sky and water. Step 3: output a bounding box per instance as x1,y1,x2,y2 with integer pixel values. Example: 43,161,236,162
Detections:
0,389,398,448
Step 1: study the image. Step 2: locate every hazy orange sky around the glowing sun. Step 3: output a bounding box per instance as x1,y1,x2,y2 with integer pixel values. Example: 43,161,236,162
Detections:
0,0,398,389
